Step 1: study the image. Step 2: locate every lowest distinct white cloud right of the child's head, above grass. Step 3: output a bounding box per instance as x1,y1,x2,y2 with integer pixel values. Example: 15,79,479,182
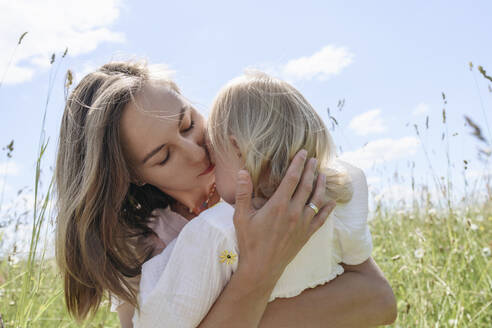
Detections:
340,137,420,169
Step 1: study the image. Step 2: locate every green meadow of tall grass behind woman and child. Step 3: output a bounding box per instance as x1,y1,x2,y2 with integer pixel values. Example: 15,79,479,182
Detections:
0,48,492,327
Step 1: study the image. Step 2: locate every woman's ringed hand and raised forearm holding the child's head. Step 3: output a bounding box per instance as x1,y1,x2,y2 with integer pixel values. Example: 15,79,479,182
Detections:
198,150,335,328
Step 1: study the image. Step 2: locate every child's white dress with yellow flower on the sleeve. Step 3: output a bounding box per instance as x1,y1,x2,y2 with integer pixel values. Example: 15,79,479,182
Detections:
133,161,372,328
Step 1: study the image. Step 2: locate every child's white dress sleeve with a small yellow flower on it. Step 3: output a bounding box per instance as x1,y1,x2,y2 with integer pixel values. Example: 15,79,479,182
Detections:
133,218,238,327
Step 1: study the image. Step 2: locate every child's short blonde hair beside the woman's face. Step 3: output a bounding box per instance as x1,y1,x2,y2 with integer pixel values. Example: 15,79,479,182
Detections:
208,71,352,203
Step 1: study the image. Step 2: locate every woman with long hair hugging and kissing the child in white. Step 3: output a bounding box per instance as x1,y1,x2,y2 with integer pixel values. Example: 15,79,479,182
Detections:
56,62,396,327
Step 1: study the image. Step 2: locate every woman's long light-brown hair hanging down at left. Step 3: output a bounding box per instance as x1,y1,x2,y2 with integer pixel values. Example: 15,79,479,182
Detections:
55,61,179,321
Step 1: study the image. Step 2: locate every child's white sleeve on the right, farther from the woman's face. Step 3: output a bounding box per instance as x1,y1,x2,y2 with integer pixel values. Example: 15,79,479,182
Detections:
333,161,372,265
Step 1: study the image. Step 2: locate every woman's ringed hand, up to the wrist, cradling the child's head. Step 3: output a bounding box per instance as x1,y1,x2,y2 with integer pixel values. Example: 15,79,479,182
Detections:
234,150,335,288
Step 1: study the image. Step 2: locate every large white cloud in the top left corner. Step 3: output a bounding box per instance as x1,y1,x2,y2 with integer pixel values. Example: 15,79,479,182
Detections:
0,0,124,84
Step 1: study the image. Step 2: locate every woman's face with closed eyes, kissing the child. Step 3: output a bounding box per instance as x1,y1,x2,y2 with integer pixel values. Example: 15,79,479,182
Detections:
120,82,214,201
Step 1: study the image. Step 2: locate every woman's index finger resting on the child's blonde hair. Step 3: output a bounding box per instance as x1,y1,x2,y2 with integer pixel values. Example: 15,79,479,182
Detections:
268,149,307,207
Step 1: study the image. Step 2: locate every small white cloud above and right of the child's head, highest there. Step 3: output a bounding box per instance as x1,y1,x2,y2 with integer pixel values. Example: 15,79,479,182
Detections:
278,45,354,80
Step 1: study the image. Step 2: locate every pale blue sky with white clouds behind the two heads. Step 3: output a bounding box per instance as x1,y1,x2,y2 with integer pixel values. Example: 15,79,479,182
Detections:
0,0,492,236
